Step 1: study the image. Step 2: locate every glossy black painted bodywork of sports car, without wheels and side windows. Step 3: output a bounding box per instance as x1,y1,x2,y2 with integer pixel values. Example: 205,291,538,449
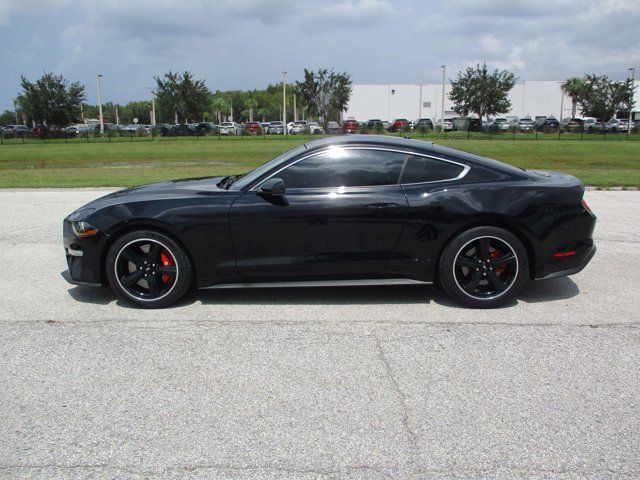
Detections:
63,136,595,288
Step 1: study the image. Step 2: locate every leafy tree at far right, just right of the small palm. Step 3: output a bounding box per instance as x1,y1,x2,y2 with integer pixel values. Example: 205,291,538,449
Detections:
580,74,633,125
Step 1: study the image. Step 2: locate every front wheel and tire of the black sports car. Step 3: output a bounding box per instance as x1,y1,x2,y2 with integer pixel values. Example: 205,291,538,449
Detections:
105,230,193,308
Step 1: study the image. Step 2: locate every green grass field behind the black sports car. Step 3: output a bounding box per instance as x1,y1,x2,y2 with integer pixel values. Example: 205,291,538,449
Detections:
0,137,640,188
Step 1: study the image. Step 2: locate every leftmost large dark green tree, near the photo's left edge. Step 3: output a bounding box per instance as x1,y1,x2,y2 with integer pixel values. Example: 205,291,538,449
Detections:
16,73,85,127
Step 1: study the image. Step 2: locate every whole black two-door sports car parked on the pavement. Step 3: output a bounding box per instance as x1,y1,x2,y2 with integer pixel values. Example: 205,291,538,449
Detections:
63,135,596,307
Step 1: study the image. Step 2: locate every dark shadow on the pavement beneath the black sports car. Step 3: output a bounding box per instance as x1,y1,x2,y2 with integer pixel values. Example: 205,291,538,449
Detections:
68,277,580,308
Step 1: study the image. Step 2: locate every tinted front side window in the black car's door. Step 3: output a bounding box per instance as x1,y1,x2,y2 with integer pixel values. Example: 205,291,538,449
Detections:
276,148,406,189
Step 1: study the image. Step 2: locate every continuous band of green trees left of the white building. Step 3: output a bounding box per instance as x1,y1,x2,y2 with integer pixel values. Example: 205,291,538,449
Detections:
0,69,352,127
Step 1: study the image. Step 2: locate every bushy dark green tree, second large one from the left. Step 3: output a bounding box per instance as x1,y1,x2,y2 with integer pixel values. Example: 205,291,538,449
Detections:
154,71,211,123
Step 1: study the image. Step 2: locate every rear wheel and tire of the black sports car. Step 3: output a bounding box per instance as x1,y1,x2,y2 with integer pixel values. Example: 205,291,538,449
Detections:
438,227,529,308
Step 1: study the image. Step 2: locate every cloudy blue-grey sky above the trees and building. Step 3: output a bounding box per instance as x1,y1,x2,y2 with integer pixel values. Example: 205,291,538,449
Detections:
0,0,640,109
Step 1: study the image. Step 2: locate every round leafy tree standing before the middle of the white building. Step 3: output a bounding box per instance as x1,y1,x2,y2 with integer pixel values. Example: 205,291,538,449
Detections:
449,63,517,120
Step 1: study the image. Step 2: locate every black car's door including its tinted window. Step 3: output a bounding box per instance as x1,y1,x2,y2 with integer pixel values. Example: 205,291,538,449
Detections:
230,147,408,281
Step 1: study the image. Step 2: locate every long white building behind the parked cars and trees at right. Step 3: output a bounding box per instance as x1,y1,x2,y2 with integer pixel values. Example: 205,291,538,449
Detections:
343,80,640,121
